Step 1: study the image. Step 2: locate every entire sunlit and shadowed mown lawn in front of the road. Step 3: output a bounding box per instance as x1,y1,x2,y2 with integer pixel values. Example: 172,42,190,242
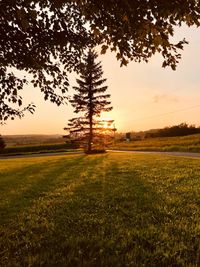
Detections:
0,154,200,267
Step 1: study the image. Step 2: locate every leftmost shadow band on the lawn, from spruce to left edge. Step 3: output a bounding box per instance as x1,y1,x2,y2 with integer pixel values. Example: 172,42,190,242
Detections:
0,156,83,224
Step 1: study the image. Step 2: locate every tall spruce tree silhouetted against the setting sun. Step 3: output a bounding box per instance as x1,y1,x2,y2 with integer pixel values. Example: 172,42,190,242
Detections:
65,49,112,153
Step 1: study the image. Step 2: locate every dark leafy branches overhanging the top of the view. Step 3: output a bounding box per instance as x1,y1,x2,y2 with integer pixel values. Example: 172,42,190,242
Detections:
0,0,200,121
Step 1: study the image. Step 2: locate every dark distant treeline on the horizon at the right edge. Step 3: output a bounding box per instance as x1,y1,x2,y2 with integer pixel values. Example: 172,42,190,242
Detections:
145,123,200,138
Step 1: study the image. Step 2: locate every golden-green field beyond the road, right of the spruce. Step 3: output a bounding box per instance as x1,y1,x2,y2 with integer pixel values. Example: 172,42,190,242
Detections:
111,134,200,153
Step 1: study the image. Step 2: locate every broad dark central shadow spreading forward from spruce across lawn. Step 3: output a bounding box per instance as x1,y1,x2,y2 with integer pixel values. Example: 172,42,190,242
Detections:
16,161,173,266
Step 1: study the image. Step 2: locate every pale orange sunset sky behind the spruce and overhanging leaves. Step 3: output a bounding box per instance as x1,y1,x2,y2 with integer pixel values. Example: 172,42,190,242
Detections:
0,27,200,135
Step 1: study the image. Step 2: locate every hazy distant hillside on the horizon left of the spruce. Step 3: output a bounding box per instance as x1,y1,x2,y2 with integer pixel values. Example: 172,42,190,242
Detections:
3,134,65,147
